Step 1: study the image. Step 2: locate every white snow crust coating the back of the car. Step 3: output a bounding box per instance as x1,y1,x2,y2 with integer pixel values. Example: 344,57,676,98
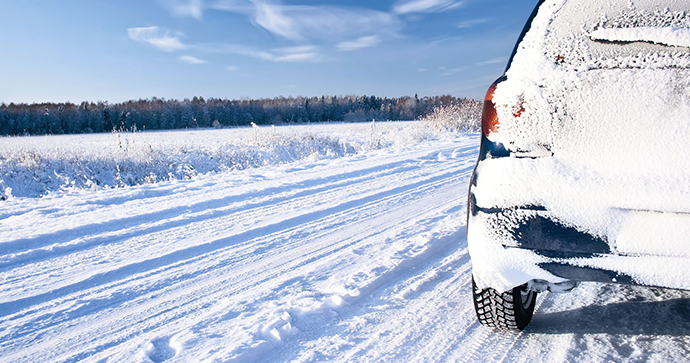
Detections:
470,0,690,288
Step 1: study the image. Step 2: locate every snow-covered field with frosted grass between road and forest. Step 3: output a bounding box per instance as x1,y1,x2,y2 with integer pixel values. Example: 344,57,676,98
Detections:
0,122,440,199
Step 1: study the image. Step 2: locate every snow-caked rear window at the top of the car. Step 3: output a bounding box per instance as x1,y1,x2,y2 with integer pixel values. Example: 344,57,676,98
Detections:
544,0,690,70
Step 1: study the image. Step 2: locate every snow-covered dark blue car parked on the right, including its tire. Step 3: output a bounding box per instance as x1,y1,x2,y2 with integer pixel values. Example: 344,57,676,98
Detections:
467,0,690,330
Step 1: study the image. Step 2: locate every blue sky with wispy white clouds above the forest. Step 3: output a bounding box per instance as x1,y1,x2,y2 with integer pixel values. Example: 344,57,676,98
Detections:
0,0,536,103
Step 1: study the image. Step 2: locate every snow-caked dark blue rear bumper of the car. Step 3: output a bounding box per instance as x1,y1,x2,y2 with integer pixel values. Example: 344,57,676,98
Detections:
467,135,690,291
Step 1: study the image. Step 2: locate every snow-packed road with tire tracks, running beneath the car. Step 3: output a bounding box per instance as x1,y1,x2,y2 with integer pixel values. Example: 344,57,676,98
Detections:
0,135,690,362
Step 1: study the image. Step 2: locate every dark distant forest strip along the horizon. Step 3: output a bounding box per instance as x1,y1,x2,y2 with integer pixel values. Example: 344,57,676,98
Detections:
0,95,468,135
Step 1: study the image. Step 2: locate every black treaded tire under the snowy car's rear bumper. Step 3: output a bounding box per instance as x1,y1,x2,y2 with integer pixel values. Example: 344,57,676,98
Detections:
472,278,537,330
